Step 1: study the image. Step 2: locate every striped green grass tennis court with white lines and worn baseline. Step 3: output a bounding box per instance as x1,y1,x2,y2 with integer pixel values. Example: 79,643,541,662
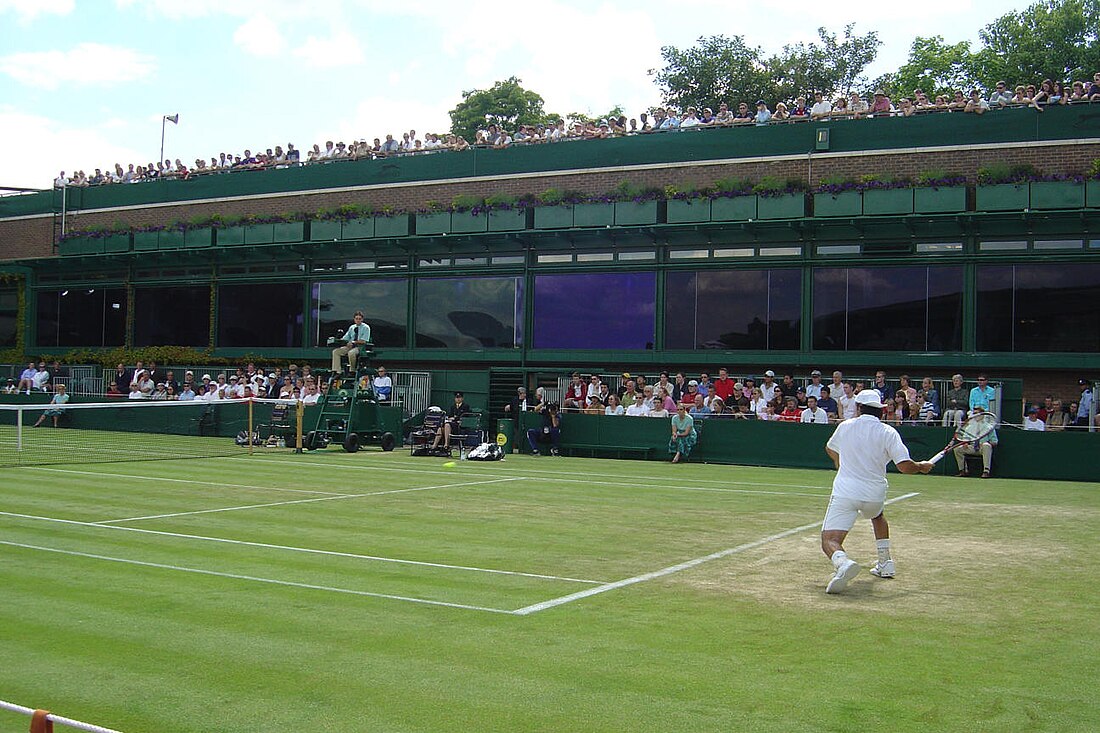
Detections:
0,450,1100,733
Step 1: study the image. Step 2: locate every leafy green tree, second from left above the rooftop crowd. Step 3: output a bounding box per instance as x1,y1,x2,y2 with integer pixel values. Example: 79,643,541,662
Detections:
649,35,774,109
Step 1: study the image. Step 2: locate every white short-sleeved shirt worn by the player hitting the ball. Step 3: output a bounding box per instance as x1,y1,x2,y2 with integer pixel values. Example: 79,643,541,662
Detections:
826,415,911,502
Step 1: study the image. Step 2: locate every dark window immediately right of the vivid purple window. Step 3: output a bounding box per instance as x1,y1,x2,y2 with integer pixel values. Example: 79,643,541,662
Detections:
664,270,802,349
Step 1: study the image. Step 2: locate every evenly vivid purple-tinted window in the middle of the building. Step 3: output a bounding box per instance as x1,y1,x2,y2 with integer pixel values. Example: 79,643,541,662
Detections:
534,272,657,349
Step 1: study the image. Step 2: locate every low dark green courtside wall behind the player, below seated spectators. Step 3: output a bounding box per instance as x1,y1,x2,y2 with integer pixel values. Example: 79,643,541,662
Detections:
516,413,1100,481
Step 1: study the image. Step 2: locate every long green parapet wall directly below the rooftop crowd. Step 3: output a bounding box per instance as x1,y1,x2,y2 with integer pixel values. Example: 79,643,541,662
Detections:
0,105,1100,218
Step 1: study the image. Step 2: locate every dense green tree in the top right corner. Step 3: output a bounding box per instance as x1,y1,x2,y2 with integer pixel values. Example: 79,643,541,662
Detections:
975,0,1100,88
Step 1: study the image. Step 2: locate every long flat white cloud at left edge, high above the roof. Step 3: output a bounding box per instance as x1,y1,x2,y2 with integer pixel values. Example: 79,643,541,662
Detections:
0,43,156,89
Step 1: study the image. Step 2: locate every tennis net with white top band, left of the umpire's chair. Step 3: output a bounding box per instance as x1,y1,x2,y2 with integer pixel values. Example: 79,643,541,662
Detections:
0,400,300,467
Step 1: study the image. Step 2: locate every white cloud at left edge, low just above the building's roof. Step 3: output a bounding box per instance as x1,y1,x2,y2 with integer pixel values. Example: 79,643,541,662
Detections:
0,108,149,188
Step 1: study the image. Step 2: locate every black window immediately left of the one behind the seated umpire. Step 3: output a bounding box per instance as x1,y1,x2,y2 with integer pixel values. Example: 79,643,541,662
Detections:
218,283,305,348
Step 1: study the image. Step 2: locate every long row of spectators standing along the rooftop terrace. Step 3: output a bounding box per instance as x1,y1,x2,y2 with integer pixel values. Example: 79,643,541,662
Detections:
54,72,1100,188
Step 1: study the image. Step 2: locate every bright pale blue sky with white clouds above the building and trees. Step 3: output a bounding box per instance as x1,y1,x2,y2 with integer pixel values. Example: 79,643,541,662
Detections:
0,0,1030,188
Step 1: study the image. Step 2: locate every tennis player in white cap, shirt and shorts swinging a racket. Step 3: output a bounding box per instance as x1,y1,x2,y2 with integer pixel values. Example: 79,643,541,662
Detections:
822,390,935,593
